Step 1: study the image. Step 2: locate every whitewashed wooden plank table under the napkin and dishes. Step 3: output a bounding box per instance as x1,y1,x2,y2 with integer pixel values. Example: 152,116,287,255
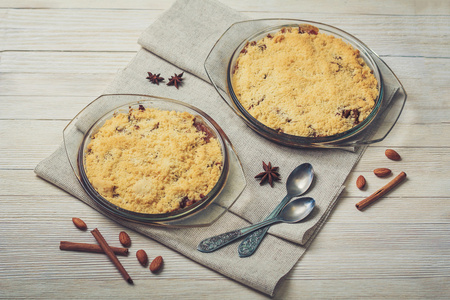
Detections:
0,0,450,299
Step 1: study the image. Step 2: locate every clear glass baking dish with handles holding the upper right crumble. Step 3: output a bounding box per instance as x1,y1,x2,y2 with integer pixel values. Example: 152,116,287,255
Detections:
204,19,406,149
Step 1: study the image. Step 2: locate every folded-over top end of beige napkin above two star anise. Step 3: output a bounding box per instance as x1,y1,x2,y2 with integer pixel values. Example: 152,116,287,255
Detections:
138,0,246,81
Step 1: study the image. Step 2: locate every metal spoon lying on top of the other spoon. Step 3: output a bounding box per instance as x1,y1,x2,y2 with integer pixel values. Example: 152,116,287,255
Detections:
197,197,316,252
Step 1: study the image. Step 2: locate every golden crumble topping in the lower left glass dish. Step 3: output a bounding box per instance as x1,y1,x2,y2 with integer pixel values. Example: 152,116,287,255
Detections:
85,105,223,214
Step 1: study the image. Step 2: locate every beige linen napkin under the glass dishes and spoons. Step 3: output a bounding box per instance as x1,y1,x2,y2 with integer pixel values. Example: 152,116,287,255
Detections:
35,0,400,295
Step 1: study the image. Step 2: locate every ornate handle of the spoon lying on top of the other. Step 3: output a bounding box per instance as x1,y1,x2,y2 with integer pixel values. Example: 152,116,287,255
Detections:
197,218,281,252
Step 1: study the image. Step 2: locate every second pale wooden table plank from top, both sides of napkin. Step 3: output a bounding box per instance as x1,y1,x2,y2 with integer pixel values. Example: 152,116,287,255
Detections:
0,9,450,57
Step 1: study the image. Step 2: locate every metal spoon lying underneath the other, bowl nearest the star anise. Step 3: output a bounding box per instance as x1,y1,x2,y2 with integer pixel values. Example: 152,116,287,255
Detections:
238,163,314,257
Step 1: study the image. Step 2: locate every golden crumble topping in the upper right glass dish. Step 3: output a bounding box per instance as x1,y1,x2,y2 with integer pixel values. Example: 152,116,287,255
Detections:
232,24,379,137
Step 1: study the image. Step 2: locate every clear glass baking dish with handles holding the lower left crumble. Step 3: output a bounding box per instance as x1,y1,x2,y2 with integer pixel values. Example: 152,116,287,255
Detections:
63,94,245,227
